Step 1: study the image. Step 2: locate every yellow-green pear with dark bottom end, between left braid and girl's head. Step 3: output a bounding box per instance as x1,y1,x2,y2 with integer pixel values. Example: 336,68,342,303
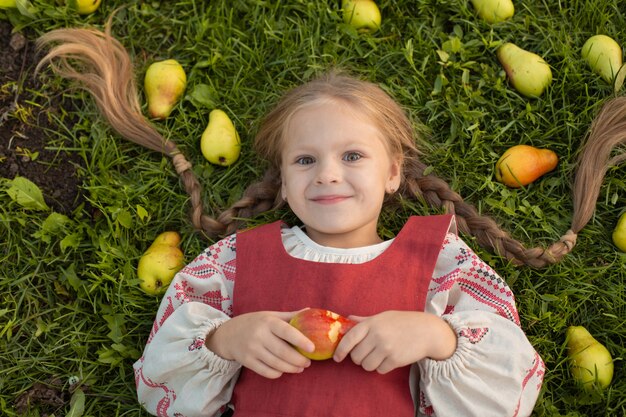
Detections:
200,109,241,166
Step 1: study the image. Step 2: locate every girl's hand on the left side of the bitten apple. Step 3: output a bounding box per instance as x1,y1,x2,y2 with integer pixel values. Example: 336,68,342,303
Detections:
205,311,315,379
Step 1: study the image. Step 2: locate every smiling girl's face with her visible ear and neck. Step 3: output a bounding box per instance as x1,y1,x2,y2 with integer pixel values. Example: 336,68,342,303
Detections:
281,101,400,248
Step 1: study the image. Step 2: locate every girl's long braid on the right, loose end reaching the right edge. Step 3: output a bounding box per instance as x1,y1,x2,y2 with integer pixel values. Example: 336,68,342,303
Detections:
403,91,626,268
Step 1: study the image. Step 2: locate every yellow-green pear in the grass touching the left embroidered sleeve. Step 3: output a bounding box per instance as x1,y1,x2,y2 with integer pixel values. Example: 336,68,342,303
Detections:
137,231,184,295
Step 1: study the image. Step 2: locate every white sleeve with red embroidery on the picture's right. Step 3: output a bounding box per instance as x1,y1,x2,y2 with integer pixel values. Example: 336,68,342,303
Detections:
418,234,545,417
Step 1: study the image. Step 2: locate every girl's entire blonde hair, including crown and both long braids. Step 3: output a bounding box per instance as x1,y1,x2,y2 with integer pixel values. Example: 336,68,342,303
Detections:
37,19,626,267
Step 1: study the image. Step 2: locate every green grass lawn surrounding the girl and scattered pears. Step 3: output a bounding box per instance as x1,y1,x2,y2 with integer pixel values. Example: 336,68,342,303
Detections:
0,0,626,416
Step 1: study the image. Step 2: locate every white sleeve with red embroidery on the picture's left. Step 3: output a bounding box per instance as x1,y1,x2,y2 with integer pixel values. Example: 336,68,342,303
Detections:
134,235,240,417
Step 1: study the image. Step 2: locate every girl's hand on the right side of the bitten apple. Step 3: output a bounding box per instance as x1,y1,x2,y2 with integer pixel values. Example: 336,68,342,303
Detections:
333,311,456,374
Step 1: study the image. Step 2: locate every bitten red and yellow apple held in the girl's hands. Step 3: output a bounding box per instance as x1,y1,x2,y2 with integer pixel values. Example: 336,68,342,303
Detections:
289,308,356,361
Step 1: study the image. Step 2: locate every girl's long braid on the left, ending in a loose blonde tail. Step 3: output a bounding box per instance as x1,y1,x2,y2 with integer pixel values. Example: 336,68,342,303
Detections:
36,16,280,238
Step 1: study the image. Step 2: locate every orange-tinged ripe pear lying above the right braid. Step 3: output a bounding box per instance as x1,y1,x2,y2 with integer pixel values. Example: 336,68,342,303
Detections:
496,145,559,188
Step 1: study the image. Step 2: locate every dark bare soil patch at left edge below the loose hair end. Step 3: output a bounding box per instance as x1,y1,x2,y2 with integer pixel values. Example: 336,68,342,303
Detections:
0,20,83,214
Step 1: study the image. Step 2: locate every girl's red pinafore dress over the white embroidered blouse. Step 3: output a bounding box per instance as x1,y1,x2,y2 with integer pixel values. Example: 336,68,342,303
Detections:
232,215,452,417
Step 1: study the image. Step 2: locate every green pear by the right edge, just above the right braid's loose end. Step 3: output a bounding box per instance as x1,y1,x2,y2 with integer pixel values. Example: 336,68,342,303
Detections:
582,35,622,83
